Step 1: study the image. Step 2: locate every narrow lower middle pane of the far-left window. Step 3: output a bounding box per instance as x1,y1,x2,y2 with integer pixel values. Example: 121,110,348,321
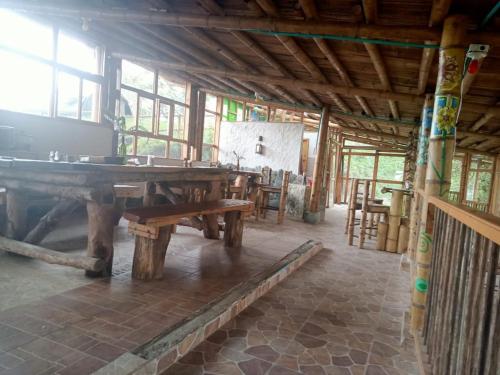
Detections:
57,72,80,118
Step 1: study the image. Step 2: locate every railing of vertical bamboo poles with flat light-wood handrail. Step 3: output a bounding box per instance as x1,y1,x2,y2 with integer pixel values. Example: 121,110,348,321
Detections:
416,197,500,375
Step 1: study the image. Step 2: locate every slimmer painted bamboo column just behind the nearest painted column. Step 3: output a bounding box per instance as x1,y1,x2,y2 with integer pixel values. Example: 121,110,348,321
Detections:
408,94,434,260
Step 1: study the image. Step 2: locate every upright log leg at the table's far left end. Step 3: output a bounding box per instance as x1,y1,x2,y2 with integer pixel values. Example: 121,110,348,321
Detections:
5,189,28,240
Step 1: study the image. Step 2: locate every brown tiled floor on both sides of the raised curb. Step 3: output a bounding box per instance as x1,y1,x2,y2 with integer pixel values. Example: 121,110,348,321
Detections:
0,208,416,375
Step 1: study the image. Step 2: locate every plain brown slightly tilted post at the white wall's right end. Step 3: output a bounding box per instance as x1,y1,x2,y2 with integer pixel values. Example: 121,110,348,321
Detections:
304,106,330,224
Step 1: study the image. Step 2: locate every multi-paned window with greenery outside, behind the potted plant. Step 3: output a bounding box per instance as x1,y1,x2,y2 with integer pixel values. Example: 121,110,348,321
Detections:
120,60,188,159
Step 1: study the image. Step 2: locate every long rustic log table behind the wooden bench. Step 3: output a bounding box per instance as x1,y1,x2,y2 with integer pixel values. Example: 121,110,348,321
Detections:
0,158,229,276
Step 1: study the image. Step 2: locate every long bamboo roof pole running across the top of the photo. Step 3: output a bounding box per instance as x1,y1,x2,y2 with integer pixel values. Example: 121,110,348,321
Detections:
0,0,446,44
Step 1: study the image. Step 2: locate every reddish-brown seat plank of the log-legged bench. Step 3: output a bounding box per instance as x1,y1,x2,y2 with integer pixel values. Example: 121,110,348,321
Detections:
123,199,254,226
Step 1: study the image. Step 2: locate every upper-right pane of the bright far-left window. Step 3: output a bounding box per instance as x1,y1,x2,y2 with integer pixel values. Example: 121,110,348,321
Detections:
57,32,99,74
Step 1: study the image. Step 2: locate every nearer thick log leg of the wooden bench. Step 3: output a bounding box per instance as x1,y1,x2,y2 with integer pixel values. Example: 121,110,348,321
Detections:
132,225,174,280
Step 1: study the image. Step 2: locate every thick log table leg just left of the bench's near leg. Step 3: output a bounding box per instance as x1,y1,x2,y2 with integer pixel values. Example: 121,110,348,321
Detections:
85,201,116,277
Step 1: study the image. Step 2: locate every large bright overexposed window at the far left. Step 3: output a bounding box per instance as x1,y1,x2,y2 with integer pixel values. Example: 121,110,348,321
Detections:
0,10,103,122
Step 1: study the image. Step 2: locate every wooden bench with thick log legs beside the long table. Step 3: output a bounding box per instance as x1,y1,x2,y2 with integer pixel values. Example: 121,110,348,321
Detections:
123,199,254,280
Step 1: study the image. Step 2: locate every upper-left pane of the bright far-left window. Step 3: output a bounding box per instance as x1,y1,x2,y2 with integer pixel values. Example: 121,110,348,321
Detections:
0,9,54,59
